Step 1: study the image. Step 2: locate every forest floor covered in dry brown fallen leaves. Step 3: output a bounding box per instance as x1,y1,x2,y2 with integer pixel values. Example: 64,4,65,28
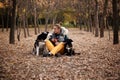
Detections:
0,28,120,80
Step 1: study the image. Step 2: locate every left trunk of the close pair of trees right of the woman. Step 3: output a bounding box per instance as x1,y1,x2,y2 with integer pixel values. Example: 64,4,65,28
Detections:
95,0,99,37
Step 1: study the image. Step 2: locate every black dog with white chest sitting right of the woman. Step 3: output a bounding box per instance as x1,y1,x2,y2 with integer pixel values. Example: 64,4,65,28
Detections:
65,39,75,56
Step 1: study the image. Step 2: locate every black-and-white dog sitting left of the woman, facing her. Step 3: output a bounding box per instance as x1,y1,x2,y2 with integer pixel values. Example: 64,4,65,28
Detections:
33,32,49,56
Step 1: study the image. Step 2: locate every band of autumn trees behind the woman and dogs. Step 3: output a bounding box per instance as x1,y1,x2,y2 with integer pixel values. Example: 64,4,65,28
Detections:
0,0,120,44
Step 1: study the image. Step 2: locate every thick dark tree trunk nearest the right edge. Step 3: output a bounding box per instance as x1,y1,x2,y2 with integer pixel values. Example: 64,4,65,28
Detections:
112,0,119,44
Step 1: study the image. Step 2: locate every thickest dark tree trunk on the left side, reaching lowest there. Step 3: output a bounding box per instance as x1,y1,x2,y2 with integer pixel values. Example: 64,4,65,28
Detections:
9,0,16,44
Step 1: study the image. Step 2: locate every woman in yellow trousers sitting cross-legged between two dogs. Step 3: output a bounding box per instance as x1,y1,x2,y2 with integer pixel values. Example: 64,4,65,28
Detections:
43,24,68,57
